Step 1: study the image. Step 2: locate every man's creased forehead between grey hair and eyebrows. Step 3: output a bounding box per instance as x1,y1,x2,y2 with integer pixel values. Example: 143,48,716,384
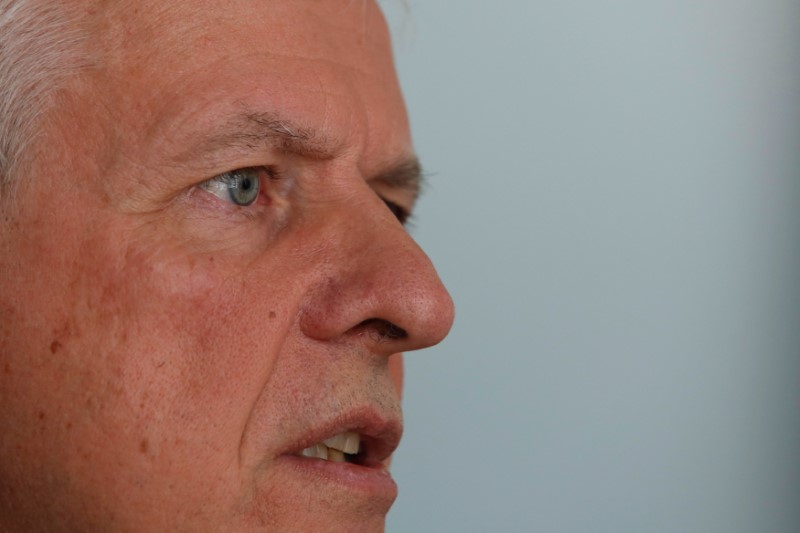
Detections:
83,0,410,166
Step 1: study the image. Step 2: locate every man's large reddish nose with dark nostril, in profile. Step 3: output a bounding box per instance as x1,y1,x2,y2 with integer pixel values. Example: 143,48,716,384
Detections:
300,182,454,355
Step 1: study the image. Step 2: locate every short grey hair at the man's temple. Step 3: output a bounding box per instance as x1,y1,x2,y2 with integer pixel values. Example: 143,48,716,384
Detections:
0,0,86,200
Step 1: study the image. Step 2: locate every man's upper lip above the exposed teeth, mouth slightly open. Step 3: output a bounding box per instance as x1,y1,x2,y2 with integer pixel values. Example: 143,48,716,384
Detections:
287,407,403,467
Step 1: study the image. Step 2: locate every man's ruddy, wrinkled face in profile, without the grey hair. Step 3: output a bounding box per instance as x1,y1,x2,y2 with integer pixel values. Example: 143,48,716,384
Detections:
0,0,453,531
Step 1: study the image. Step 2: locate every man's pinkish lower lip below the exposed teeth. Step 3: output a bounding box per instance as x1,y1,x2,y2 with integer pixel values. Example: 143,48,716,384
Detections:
279,455,397,503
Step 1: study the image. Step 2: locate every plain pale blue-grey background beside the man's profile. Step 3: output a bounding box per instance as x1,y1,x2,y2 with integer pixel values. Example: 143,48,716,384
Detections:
383,0,800,533
